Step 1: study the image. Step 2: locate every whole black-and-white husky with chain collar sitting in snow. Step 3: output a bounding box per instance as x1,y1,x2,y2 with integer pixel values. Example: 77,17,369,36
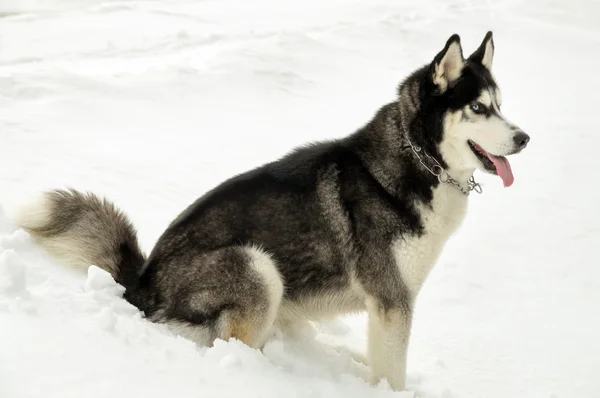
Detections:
18,32,529,390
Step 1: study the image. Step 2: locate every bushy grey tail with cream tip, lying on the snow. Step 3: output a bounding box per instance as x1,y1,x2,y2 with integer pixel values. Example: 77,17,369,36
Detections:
16,189,145,288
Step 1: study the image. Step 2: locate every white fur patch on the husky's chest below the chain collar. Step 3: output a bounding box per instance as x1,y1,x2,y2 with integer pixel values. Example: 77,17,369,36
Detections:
392,184,468,297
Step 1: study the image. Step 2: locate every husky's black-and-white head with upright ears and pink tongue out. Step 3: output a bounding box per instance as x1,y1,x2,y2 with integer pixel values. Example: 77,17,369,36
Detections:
410,32,529,187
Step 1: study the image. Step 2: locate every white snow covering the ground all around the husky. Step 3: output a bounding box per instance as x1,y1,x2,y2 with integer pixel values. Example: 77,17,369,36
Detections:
0,0,600,398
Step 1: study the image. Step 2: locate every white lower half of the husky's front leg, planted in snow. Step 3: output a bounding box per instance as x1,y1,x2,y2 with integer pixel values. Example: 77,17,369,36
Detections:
367,298,412,391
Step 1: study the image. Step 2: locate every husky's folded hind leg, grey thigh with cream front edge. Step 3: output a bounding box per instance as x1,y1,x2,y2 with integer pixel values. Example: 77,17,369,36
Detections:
154,246,283,348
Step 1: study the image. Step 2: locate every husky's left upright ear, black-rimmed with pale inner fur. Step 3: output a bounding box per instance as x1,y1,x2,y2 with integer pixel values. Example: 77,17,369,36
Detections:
431,34,465,93
